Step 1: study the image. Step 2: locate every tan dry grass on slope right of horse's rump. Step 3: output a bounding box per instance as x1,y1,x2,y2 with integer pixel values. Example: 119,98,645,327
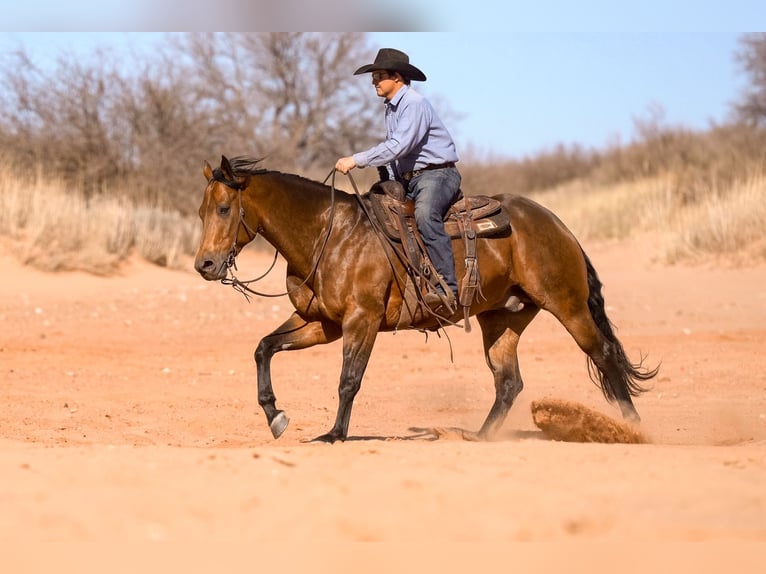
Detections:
533,175,766,264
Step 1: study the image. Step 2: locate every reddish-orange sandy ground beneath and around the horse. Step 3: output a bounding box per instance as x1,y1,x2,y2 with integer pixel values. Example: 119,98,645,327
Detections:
0,238,766,572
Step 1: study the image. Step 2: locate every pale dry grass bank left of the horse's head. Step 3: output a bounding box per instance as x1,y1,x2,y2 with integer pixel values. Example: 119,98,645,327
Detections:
0,168,199,274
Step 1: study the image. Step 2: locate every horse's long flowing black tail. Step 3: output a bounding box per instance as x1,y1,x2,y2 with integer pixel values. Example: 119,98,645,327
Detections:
583,251,660,401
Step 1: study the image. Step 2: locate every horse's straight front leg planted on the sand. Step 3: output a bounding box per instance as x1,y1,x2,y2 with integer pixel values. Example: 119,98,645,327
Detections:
314,312,380,443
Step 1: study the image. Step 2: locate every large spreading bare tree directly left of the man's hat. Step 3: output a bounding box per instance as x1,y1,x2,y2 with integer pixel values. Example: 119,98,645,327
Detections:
172,33,379,170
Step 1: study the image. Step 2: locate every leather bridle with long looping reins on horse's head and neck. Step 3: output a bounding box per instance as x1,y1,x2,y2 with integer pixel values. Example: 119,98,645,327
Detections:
213,168,340,301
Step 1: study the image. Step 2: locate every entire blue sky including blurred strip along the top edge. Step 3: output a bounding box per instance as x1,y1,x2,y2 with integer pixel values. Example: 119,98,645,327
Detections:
0,0,766,158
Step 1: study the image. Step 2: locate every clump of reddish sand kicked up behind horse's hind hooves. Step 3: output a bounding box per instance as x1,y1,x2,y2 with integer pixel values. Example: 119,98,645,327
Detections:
532,399,649,444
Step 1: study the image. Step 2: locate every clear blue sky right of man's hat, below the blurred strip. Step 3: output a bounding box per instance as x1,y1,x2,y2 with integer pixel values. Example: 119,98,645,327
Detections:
372,32,746,156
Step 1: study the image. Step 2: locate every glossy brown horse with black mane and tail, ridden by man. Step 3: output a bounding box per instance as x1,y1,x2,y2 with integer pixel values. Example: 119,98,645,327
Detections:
194,157,657,442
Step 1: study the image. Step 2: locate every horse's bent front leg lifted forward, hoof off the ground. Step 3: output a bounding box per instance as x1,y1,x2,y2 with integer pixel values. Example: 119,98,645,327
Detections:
255,313,341,438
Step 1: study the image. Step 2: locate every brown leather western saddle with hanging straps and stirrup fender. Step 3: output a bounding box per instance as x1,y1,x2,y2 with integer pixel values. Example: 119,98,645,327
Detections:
366,180,511,332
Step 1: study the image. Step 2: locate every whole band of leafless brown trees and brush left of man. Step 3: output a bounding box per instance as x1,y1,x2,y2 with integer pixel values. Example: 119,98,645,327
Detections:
0,33,380,212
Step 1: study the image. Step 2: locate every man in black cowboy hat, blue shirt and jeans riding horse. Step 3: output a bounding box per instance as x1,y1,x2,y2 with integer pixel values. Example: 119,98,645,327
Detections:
335,48,461,312
